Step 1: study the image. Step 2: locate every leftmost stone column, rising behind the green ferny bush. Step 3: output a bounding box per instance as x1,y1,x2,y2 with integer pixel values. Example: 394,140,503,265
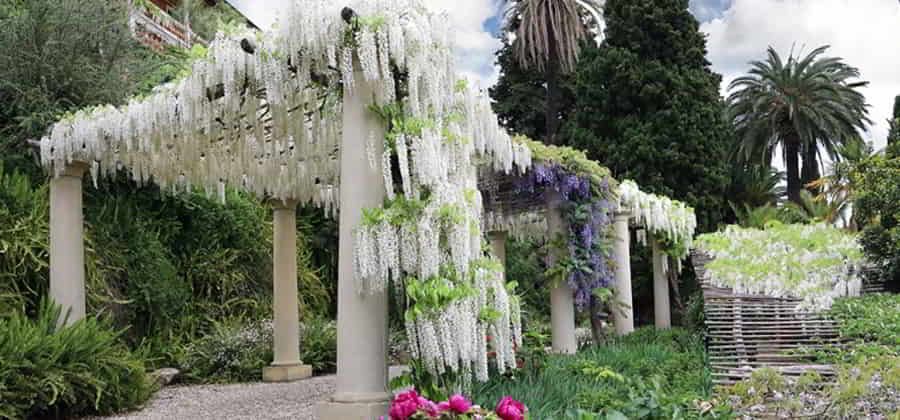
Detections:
50,162,88,324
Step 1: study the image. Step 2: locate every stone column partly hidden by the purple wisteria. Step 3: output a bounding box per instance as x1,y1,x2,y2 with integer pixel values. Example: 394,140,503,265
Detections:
547,192,578,354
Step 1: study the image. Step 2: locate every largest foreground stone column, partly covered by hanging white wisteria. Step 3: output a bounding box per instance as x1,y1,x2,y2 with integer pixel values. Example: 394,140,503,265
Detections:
318,67,390,420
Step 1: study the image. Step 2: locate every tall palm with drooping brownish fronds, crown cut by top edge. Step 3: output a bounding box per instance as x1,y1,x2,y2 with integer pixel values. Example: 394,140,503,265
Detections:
506,0,602,144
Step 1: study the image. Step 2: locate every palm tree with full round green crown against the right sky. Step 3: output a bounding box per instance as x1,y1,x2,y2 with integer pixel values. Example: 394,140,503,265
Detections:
728,46,870,204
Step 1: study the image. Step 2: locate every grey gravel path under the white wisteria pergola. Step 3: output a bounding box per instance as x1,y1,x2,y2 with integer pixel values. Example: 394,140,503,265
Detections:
94,376,334,420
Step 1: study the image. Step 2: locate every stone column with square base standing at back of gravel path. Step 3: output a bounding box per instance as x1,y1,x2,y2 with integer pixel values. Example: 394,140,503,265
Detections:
263,200,312,382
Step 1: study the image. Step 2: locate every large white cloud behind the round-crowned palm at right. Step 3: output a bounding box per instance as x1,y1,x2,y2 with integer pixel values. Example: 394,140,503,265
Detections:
700,0,900,148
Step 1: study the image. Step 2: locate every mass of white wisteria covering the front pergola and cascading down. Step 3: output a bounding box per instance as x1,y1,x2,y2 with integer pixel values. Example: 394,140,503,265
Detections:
41,0,531,388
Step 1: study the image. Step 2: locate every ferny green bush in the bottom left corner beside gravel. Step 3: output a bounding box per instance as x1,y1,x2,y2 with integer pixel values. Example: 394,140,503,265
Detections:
0,302,153,419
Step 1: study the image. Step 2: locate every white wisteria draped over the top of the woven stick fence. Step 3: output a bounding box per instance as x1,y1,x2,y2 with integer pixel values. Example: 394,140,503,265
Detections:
696,224,863,310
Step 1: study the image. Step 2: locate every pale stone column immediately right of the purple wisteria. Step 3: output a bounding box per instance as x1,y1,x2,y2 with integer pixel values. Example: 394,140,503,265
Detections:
612,212,634,335
